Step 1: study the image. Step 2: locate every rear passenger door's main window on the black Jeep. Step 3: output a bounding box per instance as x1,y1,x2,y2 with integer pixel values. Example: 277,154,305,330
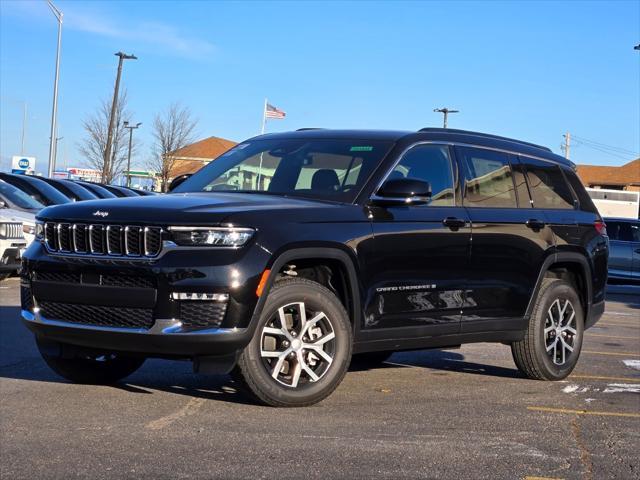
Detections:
458,147,517,208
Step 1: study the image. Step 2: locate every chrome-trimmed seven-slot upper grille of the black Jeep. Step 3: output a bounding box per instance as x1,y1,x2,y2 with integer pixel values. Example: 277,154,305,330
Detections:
44,222,162,257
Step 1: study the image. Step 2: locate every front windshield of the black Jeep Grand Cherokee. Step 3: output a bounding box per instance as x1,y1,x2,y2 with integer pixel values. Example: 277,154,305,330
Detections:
172,138,393,202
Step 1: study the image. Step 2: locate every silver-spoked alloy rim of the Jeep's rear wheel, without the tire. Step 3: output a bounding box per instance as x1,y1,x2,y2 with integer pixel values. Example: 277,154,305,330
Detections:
544,298,577,366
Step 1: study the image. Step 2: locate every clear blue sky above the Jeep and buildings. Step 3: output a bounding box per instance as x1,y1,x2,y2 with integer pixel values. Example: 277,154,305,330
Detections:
0,0,640,170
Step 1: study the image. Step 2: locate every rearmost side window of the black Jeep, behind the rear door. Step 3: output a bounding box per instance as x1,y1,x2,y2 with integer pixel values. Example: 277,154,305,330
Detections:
520,157,574,209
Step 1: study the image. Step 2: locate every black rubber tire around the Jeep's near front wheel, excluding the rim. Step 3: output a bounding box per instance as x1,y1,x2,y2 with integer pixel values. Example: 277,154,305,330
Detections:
243,279,352,406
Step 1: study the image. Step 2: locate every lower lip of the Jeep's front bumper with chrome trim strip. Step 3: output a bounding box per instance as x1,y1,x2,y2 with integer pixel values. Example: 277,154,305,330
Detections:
22,309,251,358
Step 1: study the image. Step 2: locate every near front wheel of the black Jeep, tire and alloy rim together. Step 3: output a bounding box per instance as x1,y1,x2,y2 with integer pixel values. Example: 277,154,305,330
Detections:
232,278,352,407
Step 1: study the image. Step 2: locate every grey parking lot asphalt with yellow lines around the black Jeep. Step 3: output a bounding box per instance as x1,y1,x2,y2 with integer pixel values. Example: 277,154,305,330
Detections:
0,278,640,480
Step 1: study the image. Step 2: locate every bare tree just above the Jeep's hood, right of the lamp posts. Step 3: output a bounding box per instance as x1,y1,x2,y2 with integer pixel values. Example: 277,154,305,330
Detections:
150,102,198,192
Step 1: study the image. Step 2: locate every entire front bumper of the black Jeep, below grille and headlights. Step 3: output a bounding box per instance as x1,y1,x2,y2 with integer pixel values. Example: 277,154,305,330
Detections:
21,242,268,358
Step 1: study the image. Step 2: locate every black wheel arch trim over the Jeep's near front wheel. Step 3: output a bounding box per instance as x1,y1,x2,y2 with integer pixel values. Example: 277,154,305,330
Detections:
248,247,362,335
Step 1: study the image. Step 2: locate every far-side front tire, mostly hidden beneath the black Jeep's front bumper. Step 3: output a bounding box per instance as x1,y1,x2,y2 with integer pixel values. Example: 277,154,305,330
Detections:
36,340,145,385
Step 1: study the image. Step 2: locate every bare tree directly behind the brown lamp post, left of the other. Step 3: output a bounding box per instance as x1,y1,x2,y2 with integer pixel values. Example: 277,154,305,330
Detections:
78,91,137,183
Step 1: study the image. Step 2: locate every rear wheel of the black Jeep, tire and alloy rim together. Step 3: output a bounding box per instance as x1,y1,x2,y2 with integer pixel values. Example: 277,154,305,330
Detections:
511,278,584,380
